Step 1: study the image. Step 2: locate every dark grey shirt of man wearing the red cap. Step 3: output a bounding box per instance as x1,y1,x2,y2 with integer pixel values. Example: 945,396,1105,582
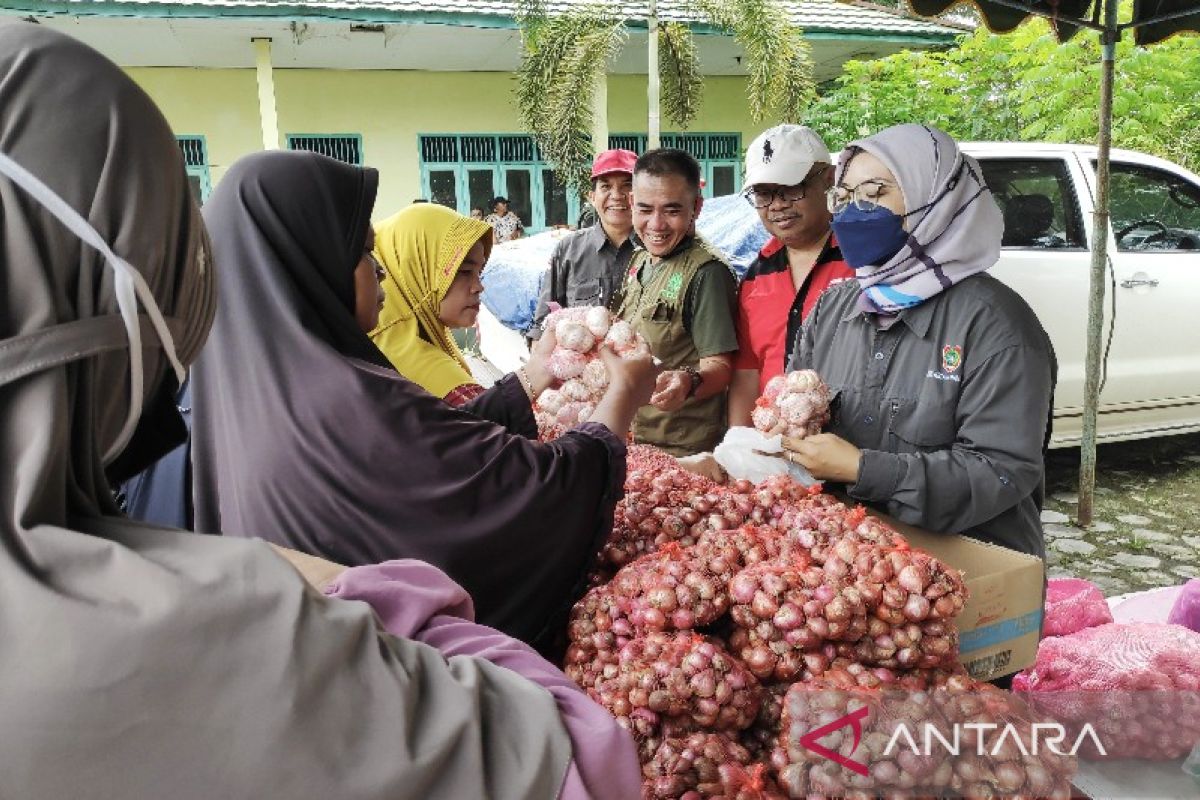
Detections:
527,223,634,338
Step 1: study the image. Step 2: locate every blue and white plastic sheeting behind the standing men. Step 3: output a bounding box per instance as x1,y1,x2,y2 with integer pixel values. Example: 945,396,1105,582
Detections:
482,194,767,333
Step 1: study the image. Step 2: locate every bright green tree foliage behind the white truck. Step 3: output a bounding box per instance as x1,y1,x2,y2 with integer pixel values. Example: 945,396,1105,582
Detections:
805,19,1200,172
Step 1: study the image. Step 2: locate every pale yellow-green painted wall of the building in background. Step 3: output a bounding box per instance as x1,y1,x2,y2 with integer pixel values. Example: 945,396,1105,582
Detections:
127,67,775,219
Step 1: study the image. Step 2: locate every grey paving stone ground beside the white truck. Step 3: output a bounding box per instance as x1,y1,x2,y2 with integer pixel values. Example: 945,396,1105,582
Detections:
1042,434,1200,595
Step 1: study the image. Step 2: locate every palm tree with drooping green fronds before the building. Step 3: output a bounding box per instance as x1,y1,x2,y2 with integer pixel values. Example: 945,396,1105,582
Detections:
516,0,816,191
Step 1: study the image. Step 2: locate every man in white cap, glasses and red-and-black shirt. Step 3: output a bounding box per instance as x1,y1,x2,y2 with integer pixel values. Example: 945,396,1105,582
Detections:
730,125,854,426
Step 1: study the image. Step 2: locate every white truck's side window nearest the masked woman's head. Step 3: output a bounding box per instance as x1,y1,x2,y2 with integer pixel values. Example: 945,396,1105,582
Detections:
979,156,1087,249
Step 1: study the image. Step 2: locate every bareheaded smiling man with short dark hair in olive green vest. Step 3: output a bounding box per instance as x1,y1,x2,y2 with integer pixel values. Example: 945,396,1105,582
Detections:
617,148,738,456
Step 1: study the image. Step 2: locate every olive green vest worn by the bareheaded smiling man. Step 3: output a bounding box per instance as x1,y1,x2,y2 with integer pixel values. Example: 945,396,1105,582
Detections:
617,239,727,456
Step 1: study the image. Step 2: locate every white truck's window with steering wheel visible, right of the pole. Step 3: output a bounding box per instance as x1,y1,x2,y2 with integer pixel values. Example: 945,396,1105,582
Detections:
1093,162,1200,252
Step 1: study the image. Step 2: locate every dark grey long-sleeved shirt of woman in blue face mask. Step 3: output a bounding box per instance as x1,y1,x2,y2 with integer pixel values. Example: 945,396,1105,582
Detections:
787,275,1057,557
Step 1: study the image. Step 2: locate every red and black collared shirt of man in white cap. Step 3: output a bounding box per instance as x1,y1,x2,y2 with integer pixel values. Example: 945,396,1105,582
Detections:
733,234,854,393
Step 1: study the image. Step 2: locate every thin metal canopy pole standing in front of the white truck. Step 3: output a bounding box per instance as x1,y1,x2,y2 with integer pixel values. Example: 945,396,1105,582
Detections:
1078,0,1121,527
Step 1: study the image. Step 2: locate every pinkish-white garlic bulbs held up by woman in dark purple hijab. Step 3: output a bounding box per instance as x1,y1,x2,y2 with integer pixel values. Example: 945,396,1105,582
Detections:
534,306,649,439
